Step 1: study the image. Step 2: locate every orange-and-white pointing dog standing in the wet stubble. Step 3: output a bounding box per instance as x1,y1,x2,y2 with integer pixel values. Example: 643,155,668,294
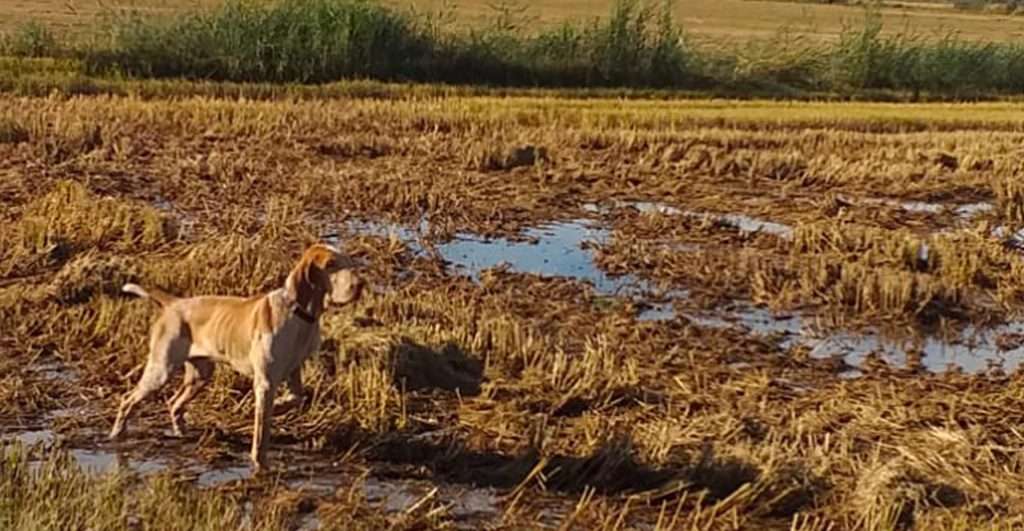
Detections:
110,244,362,471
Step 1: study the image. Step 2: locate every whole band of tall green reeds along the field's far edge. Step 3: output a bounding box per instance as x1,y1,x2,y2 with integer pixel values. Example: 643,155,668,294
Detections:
8,0,1024,98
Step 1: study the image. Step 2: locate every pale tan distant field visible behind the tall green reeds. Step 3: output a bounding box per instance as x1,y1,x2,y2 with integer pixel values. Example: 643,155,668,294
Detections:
6,0,1024,40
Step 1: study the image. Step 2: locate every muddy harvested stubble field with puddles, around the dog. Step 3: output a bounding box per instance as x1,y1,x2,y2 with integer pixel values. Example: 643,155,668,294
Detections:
0,91,1024,530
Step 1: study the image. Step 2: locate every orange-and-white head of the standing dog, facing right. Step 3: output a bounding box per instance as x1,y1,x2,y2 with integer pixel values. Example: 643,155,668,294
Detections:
287,244,365,306
